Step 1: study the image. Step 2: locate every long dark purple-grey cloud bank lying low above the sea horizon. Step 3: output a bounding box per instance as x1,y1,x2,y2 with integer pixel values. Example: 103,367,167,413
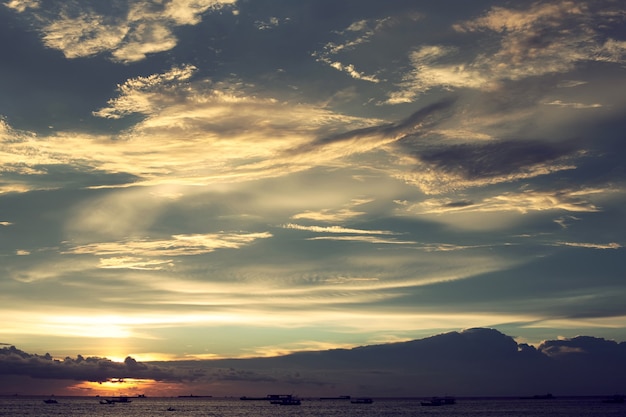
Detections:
0,328,626,396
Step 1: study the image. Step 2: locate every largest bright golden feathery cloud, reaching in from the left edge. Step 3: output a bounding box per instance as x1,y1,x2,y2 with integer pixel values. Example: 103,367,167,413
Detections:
0,65,380,192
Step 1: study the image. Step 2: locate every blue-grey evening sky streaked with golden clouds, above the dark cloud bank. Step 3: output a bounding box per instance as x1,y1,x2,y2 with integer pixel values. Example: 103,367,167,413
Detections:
0,0,626,394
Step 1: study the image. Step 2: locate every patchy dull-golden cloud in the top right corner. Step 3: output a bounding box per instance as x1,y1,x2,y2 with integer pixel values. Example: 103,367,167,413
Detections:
387,0,626,104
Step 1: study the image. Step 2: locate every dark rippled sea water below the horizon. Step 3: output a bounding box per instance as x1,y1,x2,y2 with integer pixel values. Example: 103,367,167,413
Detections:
0,397,626,417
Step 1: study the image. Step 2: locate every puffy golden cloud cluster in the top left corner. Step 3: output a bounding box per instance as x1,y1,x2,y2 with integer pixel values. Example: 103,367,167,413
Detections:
6,0,235,63
